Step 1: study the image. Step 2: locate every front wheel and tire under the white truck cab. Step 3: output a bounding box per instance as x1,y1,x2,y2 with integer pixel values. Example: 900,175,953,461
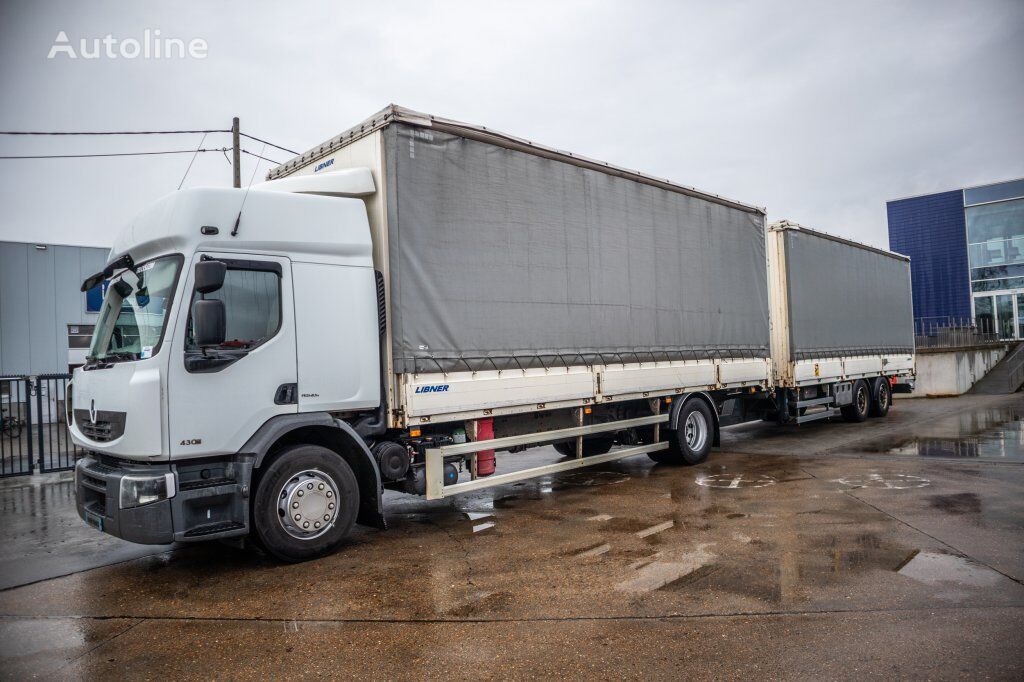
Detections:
251,445,359,562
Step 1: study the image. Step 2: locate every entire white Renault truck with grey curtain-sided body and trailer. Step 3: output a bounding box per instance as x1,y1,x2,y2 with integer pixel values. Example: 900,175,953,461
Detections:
72,106,913,561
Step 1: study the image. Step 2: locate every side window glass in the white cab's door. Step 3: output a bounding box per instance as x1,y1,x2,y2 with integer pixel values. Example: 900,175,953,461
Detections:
185,261,281,351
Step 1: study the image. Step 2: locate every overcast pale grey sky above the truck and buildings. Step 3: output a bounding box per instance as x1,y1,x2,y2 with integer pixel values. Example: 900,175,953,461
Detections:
0,0,1024,246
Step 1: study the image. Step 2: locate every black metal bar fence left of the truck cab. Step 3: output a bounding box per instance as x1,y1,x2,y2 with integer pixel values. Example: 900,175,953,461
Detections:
0,374,85,478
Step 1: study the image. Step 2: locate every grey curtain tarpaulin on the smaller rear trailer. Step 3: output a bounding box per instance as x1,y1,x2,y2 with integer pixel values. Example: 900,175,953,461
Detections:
784,229,913,359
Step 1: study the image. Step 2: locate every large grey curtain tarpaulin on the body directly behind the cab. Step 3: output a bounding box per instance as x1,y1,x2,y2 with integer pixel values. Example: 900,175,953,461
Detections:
384,124,769,373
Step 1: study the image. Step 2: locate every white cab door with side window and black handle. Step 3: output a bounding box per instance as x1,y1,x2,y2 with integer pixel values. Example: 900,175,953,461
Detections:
167,253,297,458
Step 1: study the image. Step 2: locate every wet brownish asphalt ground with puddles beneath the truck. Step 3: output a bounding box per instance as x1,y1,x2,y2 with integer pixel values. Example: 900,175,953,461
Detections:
0,395,1024,679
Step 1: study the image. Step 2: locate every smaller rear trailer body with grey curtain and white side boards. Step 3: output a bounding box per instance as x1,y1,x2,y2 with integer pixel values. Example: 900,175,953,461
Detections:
768,221,914,403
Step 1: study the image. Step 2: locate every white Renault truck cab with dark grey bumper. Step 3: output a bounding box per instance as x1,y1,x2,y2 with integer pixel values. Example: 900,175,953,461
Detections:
67,174,383,559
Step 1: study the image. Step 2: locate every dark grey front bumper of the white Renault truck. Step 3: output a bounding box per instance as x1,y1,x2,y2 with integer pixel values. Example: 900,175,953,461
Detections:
75,453,252,545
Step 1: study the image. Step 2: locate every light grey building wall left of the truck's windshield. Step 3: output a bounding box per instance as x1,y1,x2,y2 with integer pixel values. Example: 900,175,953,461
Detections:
0,242,110,376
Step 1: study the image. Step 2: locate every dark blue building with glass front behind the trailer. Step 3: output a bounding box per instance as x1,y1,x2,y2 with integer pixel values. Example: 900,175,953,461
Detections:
886,178,1024,338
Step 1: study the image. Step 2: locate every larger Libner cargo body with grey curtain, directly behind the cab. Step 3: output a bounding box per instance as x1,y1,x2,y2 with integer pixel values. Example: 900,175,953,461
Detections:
268,106,771,428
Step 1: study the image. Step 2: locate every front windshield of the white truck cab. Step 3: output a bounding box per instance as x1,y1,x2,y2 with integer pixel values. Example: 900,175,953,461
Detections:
88,255,182,363
